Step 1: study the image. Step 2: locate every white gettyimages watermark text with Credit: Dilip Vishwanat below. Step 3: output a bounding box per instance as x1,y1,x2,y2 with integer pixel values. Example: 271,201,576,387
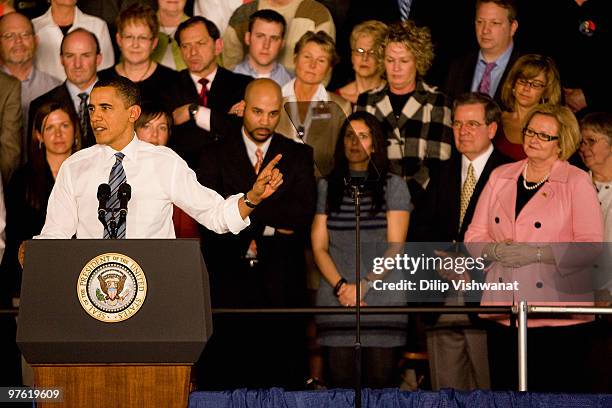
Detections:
371,254,519,293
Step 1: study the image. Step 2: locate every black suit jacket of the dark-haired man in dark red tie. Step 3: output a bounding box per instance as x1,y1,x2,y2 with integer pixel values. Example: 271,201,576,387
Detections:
170,67,253,169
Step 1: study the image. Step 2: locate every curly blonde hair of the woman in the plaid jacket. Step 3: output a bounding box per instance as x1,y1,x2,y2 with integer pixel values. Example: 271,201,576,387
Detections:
382,20,434,76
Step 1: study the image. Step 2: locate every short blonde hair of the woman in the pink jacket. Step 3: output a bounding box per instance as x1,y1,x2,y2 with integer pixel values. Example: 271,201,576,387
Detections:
523,103,582,160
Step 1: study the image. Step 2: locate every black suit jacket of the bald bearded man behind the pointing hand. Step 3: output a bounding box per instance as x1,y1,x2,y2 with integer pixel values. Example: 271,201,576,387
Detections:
198,129,316,306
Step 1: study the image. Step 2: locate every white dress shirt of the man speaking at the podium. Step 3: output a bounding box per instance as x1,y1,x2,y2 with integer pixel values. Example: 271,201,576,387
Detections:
35,136,250,239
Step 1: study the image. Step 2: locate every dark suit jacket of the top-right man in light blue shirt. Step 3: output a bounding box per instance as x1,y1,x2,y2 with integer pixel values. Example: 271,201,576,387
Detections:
443,43,523,106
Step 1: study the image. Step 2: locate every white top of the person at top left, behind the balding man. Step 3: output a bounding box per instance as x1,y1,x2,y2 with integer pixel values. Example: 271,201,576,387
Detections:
32,7,115,81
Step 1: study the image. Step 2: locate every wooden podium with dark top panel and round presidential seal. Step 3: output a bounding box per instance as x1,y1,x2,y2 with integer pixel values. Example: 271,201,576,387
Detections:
17,240,212,408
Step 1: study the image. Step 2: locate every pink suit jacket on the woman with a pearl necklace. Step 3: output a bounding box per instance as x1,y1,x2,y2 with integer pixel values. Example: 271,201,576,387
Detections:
465,160,603,326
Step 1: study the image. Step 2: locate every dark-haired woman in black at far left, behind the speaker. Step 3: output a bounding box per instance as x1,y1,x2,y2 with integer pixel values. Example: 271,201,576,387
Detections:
2,102,81,296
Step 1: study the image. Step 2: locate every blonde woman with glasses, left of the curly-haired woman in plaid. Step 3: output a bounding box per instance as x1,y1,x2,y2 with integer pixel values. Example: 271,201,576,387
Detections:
338,20,387,104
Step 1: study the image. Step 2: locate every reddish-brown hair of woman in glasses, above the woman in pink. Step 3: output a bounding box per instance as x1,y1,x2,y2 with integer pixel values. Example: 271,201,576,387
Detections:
501,54,561,112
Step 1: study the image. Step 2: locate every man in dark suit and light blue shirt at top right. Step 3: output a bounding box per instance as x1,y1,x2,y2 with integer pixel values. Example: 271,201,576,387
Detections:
443,0,520,102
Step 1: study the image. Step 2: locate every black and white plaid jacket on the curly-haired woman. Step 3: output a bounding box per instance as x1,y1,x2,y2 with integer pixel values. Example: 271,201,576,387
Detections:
355,79,453,199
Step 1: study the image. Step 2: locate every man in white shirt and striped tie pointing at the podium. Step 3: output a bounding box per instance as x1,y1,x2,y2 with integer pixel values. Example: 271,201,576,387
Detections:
36,77,283,239
